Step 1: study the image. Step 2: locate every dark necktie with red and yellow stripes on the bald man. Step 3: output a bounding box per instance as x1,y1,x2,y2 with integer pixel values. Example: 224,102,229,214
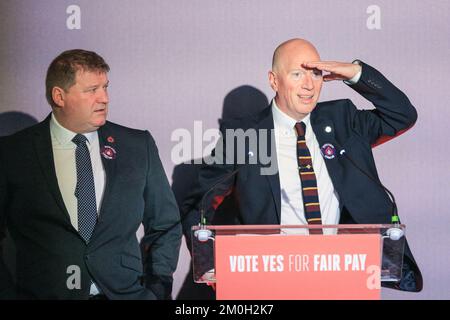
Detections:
295,122,322,233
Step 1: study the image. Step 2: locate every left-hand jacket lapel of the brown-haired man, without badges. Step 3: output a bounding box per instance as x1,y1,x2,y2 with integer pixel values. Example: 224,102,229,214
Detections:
33,116,72,225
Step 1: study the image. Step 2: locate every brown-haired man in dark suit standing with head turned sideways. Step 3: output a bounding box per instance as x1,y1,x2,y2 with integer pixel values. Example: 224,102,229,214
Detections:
0,50,181,299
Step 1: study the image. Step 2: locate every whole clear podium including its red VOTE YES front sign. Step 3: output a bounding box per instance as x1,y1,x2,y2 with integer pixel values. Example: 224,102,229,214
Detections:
192,224,405,300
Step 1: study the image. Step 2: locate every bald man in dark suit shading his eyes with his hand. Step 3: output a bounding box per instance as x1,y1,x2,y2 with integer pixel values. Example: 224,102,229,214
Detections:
182,39,422,291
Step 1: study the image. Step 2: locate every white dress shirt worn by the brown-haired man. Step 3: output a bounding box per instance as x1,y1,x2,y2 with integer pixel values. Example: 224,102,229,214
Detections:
50,113,106,294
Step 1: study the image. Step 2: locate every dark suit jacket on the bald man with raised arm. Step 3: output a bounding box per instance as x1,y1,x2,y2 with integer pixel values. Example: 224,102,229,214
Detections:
182,63,422,291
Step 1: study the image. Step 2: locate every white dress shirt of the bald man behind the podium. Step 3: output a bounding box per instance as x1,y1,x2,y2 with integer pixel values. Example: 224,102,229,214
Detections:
272,99,340,234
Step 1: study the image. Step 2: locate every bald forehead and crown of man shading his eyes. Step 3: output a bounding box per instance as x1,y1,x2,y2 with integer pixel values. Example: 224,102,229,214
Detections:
272,39,320,71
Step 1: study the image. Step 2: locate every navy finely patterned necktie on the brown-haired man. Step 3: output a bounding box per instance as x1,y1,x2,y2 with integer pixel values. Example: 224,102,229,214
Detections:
72,134,97,243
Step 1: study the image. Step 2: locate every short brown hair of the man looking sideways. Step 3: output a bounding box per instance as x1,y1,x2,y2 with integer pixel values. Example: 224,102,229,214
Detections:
45,49,109,107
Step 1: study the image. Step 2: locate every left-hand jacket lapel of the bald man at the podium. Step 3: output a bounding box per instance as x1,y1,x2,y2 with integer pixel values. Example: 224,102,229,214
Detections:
256,107,281,222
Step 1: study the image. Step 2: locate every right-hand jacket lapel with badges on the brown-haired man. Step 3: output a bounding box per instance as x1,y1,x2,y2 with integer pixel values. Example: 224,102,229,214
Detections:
98,123,119,219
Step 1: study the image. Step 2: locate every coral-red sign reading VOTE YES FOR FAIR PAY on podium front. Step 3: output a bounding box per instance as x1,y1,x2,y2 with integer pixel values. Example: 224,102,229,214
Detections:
215,234,382,300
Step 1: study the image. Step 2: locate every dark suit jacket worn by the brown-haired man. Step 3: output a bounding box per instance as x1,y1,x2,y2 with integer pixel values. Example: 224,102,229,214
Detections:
0,117,181,299
